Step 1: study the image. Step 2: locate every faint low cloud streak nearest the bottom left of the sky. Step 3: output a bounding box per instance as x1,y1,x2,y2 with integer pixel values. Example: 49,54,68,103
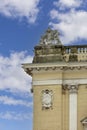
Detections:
0,111,32,120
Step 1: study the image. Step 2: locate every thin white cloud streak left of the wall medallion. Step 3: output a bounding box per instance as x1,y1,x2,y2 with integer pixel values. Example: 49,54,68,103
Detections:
0,96,33,107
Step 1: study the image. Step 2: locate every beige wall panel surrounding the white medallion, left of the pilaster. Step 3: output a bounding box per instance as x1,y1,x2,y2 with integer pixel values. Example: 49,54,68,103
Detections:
34,85,62,130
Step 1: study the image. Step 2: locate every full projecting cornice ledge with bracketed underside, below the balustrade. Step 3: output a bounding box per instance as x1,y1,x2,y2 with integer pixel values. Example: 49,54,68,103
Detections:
22,62,87,75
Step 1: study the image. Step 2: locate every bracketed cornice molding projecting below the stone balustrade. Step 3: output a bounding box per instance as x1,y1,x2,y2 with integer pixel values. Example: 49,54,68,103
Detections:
23,64,87,75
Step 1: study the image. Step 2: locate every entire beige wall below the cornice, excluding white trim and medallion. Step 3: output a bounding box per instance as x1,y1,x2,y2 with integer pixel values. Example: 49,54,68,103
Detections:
33,69,87,130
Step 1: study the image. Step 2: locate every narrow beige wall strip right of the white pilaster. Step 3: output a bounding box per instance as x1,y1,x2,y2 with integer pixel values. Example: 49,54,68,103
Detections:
78,85,87,130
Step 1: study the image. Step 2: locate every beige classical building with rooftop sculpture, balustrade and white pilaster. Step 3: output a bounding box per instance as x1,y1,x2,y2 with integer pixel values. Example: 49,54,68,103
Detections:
23,28,87,130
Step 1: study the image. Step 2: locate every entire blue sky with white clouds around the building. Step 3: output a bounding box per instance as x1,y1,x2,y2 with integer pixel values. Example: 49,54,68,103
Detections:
0,0,87,130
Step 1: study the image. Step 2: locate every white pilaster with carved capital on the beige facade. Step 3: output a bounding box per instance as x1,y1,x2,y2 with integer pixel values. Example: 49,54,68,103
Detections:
68,85,78,130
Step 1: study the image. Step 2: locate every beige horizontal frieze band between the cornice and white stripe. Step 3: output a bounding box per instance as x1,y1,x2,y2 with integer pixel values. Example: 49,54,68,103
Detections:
33,69,87,81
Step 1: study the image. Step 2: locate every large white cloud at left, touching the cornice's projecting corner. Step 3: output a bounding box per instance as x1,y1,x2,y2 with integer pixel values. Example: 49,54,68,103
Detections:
0,52,33,95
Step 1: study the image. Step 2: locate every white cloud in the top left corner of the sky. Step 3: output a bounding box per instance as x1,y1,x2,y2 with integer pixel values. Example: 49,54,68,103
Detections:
0,0,40,23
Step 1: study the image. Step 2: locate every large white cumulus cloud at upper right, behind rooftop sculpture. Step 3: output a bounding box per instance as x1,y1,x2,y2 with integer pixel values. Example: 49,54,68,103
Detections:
49,0,87,44
